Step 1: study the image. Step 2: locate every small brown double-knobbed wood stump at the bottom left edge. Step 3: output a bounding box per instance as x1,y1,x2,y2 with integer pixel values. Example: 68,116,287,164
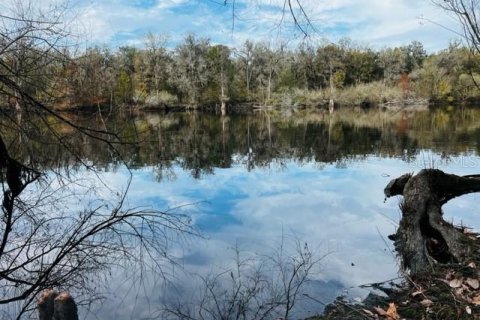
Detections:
37,289,78,320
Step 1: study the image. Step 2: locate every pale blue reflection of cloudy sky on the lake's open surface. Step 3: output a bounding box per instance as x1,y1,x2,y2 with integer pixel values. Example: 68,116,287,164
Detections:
92,151,480,318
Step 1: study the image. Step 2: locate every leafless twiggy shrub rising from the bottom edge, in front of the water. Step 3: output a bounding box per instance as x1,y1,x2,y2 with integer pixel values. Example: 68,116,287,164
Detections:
162,237,325,320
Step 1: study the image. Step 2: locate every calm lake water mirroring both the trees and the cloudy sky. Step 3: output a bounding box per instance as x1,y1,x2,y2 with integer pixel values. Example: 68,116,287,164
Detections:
5,109,480,319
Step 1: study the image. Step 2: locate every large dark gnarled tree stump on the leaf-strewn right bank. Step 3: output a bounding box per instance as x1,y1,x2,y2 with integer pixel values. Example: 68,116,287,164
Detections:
384,169,480,275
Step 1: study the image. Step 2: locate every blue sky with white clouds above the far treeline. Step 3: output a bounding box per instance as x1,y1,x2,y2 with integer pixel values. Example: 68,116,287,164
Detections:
62,0,458,51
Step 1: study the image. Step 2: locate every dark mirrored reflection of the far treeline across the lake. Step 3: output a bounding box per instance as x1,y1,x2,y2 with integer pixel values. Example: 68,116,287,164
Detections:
2,109,480,180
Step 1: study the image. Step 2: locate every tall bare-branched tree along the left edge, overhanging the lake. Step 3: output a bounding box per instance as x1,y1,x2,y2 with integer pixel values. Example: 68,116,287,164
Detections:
0,0,193,319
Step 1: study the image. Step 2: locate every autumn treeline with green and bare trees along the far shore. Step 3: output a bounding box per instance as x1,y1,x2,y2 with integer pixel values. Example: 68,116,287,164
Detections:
0,34,480,108
